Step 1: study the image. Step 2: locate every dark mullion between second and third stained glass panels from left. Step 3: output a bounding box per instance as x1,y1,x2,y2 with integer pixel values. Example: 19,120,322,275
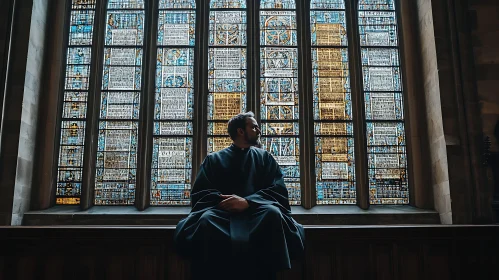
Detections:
135,1,158,210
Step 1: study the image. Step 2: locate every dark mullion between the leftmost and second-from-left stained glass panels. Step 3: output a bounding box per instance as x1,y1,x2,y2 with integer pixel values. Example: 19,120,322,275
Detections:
80,0,107,210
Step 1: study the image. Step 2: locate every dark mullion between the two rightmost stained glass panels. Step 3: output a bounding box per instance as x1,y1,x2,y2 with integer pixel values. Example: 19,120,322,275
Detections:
345,1,369,209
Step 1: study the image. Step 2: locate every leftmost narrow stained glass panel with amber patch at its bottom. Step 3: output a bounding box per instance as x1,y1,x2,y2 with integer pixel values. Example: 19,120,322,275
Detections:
56,0,95,204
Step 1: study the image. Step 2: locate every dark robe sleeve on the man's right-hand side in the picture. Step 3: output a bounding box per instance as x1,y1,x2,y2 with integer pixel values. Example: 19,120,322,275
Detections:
244,153,291,213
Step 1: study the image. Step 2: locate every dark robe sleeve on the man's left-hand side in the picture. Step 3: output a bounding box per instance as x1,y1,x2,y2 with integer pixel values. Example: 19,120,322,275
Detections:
191,156,222,212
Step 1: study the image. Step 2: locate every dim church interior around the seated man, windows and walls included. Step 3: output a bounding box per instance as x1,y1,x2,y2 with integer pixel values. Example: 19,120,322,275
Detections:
0,0,499,280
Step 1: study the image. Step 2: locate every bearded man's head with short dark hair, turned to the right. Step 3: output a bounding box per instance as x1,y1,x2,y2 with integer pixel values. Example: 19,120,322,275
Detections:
227,112,261,146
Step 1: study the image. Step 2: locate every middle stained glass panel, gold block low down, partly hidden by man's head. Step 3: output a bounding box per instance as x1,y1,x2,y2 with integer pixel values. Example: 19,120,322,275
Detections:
208,0,247,153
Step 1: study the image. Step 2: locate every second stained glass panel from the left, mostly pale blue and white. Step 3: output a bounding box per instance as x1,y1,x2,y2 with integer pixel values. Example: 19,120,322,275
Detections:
95,0,144,205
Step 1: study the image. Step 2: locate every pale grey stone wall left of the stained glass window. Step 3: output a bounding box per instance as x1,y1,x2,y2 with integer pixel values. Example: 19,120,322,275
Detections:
0,0,49,225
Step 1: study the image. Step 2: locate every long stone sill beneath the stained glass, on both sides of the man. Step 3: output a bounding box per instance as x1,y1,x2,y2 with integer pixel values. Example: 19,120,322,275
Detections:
23,205,440,226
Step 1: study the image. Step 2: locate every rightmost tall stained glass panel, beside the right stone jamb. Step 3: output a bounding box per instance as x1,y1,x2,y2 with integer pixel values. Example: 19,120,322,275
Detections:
359,0,409,204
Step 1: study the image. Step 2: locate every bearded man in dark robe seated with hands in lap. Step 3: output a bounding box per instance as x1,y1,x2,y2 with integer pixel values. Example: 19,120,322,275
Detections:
175,112,305,280
